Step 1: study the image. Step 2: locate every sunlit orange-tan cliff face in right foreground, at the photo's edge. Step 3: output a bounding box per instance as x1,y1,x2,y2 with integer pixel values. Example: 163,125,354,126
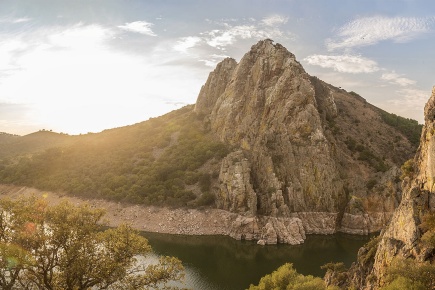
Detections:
351,87,435,289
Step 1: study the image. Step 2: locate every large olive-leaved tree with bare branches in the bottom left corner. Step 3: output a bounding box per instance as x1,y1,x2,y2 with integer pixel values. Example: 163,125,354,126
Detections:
0,197,184,290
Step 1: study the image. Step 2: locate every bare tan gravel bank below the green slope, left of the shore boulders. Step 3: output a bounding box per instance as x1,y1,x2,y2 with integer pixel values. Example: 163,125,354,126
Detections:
0,184,236,235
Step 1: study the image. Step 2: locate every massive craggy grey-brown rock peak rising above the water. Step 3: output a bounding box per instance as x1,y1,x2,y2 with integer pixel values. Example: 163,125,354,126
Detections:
195,40,415,243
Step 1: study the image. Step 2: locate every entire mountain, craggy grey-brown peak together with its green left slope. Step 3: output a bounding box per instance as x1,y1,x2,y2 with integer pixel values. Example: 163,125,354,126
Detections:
0,40,421,244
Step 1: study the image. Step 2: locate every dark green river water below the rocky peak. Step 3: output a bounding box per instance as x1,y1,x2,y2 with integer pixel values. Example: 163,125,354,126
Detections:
143,233,372,290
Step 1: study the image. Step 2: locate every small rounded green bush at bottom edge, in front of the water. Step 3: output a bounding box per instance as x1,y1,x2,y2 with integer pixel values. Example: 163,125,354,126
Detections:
249,263,327,290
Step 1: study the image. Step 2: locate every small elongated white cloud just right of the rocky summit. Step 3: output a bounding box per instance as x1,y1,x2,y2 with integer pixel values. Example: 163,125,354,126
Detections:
304,54,379,73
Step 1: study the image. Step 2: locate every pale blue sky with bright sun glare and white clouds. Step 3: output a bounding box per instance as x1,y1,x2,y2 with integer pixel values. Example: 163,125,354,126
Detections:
0,0,435,135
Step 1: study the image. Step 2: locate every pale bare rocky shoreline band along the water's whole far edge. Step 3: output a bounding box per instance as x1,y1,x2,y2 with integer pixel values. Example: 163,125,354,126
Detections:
0,185,388,245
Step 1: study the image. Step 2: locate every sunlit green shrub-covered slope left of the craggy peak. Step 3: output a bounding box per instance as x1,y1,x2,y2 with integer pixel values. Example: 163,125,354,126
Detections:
0,107,228,206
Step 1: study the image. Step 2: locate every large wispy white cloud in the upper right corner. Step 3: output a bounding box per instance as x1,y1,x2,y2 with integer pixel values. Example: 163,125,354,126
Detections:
326,16,435,51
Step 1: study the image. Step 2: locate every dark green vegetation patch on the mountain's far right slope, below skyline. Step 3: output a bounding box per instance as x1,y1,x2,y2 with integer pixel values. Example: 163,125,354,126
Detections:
379,110,423,146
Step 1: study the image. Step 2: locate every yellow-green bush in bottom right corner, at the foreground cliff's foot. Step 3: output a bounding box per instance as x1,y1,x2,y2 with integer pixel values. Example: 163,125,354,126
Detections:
382,258,435,290
